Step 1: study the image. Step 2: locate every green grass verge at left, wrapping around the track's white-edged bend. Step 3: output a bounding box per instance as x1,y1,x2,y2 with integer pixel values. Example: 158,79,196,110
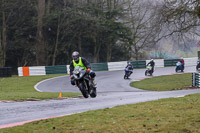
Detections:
0,75,80,101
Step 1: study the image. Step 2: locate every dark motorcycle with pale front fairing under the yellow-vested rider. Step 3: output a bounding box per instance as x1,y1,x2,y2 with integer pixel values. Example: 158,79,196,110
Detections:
73,66,97,98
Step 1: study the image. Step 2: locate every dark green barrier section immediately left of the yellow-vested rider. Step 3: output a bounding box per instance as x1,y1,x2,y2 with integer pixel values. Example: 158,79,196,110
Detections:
45,65,67,74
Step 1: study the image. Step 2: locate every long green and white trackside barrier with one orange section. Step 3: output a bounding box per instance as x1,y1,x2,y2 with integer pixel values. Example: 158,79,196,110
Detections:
18,57,198,76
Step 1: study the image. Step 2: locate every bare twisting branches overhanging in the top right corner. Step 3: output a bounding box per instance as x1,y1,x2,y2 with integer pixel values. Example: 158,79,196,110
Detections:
159,0,200,44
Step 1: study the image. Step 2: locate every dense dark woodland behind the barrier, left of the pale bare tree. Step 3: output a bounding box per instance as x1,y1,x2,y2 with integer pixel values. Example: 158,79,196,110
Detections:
0,0,145,68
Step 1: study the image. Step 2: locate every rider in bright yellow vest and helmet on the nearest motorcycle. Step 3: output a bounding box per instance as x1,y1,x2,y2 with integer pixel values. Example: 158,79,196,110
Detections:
69,51,96,86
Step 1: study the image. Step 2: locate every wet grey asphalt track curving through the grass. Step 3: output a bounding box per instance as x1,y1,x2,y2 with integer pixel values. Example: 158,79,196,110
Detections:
0,66,200,128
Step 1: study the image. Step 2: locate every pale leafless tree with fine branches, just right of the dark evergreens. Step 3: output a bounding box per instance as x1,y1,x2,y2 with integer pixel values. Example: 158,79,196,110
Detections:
126,0,160,60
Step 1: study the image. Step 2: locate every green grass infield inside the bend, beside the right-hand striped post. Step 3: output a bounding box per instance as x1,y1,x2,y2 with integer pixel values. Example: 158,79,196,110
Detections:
131,73,192,91
